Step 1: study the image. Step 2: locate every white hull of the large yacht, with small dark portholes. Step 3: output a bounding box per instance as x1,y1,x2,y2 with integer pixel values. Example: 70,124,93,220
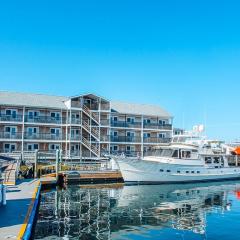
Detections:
117,158,240,183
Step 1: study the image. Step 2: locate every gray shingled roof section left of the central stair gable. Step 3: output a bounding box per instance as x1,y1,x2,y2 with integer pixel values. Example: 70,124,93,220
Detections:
0,91,69,109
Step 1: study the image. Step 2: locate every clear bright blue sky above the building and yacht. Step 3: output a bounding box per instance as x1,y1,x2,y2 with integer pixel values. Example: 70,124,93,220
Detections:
0,0,240,140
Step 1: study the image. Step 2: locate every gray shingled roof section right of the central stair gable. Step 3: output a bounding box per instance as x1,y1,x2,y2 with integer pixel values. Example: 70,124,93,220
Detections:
111,101,172,118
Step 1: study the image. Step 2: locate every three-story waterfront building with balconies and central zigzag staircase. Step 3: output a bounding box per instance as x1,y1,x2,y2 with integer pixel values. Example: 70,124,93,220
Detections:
0,91,172,158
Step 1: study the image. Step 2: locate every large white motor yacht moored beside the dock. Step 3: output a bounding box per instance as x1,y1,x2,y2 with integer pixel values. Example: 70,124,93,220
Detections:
114,136,240,184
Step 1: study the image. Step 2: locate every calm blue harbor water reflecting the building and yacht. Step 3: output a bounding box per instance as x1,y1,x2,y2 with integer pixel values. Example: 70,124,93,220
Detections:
35,182,240,240
